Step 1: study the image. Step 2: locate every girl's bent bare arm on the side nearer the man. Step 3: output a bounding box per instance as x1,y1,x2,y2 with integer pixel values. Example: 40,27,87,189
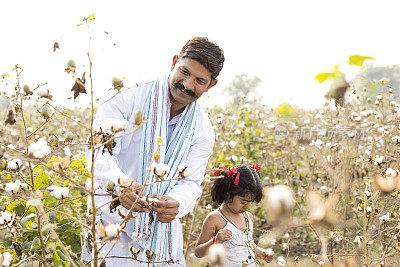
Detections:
194,214,232,258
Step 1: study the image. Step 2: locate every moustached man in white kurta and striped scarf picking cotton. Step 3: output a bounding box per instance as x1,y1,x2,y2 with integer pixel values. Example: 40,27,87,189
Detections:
83,37,224,267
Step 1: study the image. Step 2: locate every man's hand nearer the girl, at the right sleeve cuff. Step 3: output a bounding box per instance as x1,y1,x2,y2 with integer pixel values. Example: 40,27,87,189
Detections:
149,196,179,223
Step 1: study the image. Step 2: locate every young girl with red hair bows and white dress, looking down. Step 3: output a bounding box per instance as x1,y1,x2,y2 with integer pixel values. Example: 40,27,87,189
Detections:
195,164,273,267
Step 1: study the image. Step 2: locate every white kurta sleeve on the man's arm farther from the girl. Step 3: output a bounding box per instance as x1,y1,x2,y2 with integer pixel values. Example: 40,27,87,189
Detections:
85,92,133,193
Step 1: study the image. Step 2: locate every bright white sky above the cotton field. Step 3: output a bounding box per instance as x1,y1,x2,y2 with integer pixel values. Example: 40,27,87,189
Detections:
0,0,400,108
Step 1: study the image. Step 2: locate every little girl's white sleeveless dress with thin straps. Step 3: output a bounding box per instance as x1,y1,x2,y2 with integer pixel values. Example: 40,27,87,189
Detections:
217,210,258,267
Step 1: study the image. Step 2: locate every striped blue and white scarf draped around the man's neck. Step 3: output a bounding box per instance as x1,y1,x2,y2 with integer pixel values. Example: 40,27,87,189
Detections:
132,76,198,266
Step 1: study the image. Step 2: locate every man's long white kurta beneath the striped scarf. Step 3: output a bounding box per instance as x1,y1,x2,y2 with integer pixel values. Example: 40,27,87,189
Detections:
83,78,215,267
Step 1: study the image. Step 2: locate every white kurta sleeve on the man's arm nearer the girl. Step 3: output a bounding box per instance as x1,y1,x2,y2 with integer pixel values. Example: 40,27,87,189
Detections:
168,119,215,218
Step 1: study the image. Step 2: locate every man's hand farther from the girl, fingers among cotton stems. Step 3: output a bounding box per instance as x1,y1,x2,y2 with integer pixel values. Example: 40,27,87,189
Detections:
119,182,149,212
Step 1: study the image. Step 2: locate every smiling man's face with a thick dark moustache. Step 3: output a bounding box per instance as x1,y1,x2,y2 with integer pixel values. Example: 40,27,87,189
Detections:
169,56,217,107
